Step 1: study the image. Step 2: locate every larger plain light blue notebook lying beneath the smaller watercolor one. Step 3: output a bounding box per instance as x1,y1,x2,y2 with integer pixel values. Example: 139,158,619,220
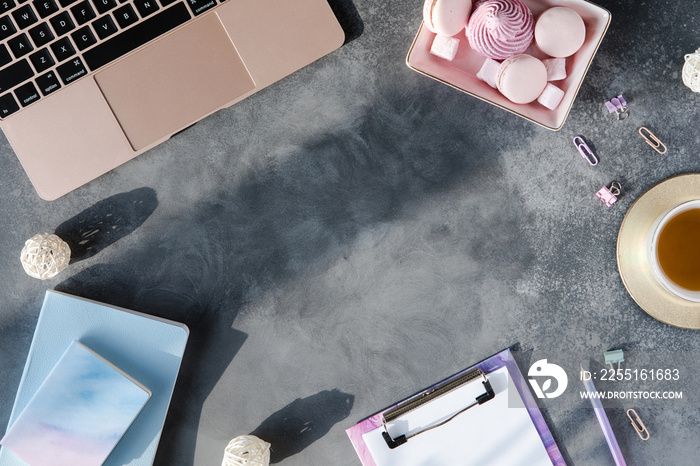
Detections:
0,291,189,466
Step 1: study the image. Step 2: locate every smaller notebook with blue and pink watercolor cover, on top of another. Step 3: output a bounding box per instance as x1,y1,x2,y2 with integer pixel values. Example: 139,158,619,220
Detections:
0,341,151,466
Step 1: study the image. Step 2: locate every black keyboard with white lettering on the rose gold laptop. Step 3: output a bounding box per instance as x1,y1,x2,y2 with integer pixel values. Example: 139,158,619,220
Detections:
0,0,225,118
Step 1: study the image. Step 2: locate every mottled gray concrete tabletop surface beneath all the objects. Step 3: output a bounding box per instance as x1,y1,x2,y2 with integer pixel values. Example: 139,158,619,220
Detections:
0,0,700,466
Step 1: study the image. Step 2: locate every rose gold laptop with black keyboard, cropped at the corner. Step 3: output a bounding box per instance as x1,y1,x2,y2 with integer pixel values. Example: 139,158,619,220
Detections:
0,0,345,200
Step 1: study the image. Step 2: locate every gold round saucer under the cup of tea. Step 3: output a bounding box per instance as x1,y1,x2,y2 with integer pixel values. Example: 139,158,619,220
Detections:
617,173,700,329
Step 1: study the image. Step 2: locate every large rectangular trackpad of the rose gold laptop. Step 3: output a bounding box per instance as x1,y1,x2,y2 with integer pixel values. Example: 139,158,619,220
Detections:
95,14,255,150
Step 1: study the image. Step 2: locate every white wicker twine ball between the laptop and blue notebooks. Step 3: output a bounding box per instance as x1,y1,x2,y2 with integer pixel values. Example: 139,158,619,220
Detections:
20,233,70,280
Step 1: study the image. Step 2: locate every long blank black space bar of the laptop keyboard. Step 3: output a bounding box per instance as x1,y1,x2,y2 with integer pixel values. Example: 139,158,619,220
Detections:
83,3,190,70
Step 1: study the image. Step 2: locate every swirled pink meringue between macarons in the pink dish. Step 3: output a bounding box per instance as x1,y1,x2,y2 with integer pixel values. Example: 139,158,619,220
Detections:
466,0,535,60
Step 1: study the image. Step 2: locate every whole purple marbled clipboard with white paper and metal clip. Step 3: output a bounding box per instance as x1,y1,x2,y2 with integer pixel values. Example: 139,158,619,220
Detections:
346,349,566,466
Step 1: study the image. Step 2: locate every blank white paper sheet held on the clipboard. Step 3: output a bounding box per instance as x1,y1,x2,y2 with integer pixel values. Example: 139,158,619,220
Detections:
363,367,552,466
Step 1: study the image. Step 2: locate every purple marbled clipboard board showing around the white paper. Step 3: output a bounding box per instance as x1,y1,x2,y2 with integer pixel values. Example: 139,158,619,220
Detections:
346,349,566,466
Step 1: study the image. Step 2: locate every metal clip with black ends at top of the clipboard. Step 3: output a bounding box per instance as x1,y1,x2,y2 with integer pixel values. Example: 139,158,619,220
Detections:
382,369,496,450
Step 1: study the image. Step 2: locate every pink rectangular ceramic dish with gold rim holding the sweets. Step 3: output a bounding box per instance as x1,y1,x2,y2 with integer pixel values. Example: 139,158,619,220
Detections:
406,0,611,131
